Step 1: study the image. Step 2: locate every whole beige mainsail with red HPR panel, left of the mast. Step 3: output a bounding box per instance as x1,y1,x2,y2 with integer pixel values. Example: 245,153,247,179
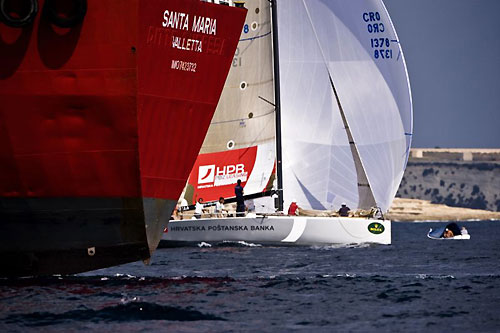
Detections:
185,0,275,203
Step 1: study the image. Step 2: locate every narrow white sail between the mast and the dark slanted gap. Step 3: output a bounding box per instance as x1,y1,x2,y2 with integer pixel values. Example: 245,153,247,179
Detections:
278,1,358,209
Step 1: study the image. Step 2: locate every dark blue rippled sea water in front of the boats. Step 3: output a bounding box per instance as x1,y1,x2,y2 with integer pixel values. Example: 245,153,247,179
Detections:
0,221,500,332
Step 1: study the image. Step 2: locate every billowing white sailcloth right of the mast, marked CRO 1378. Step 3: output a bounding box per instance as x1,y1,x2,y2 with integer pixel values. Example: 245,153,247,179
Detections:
278,0,412,211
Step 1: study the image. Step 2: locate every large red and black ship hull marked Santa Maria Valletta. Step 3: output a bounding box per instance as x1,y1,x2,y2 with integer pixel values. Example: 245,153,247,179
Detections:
0,0,246,276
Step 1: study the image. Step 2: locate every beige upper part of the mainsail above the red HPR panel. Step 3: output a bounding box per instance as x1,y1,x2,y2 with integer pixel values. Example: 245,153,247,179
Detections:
200,0,275,154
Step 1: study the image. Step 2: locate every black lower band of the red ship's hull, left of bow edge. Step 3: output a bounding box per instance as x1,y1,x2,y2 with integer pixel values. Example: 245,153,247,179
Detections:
0,198,150,277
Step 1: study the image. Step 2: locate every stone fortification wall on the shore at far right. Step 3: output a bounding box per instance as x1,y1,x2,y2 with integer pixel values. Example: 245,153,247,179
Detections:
396,149,500,211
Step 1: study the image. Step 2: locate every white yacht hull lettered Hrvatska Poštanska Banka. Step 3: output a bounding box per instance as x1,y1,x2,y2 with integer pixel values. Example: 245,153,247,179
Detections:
160,216,391,246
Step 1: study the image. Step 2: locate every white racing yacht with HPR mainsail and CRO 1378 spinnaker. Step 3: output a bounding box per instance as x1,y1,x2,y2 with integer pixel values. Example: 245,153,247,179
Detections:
162,0,413,244
